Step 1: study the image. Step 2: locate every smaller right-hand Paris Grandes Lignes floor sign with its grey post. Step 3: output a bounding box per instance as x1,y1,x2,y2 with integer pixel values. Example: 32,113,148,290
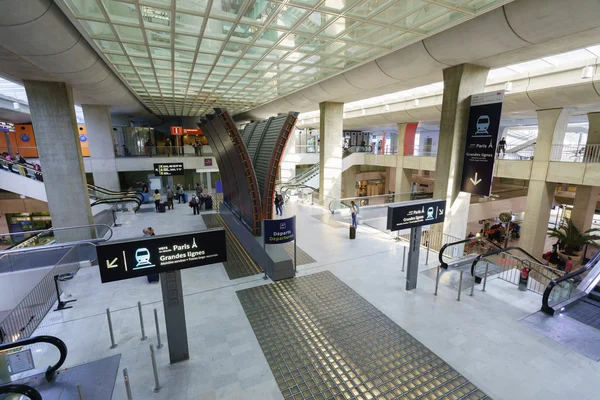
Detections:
387,200,446,290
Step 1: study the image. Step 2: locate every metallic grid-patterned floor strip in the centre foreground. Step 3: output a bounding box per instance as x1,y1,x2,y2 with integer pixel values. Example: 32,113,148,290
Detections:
237,271,488,400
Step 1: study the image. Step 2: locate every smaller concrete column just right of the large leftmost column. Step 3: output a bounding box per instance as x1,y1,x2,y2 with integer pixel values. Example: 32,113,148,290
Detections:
81,104,121,191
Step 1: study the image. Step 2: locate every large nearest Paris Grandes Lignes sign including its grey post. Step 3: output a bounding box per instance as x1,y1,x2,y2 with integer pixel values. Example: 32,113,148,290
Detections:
96,228,227,364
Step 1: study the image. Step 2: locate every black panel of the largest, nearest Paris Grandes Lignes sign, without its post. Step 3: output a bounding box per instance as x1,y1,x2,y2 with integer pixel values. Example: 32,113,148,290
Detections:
96,228,227,283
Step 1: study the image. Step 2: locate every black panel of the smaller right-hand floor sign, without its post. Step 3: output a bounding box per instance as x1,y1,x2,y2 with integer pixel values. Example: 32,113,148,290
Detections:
387,200,446,231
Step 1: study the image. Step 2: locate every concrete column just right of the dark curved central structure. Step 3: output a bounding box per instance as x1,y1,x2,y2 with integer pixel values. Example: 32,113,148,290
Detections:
319,102,344,205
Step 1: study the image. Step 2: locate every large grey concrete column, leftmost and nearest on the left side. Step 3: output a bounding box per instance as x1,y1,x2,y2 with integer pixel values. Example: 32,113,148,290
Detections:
23,80,94,242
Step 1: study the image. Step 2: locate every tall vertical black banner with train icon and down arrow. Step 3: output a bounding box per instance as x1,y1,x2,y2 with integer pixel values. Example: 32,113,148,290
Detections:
460,90,504,196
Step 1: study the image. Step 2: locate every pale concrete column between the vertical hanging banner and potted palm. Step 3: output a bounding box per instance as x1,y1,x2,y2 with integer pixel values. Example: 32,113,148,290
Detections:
520,108,571,257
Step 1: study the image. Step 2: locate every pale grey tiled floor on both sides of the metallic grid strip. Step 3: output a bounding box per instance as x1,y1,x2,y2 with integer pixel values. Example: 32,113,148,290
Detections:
14,198,600,400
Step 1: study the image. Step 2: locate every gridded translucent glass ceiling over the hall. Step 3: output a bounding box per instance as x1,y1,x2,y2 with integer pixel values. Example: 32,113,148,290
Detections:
60,0,511,115
